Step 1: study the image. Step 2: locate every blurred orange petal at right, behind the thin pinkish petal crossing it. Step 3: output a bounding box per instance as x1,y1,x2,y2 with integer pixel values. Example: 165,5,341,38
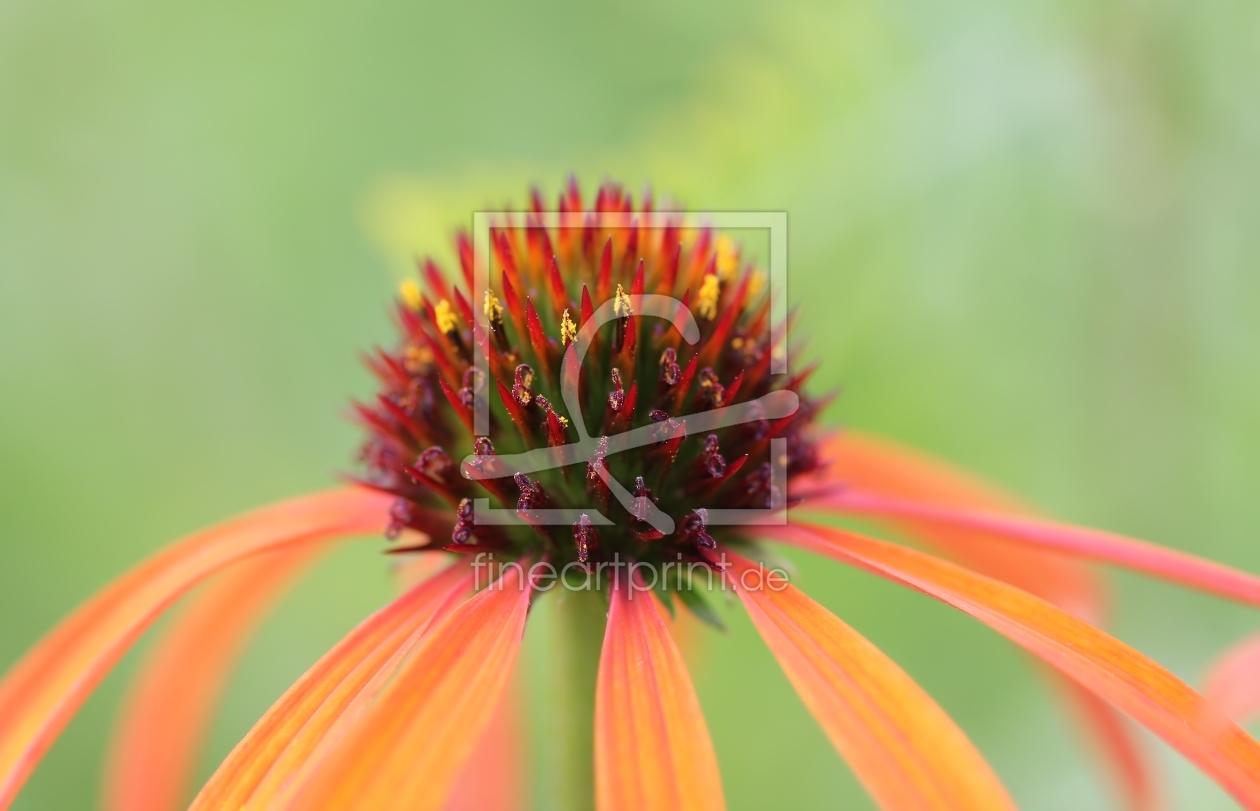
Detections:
805,431,1160,811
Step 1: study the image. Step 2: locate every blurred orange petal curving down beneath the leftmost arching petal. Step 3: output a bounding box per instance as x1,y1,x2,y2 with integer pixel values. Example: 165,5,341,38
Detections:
103,544,328,811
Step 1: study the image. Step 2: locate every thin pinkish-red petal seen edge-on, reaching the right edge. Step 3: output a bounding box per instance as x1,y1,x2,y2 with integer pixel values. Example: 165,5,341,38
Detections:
819,492,1260,606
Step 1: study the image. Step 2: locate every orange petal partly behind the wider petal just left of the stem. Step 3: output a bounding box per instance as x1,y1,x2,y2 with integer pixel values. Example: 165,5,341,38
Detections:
193,562,471,811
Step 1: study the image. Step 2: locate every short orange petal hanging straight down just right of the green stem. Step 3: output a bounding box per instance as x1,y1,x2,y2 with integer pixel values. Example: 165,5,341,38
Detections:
595,576,726,811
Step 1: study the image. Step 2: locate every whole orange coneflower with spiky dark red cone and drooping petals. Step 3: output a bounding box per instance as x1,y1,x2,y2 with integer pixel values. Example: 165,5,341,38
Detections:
0,178,1260,811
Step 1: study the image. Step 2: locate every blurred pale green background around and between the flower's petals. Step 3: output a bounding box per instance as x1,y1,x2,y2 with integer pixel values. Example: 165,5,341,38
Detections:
0,0,1260,810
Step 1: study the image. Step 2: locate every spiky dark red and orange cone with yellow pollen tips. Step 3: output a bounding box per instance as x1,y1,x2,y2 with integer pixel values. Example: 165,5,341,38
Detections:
357,183,818,574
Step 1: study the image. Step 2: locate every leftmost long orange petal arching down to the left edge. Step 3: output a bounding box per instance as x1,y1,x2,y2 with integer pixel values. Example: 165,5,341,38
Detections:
0,489,392,808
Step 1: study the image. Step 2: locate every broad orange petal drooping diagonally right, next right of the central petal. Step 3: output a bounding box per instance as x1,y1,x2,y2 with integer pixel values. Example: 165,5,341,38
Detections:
723,550,1016,810
